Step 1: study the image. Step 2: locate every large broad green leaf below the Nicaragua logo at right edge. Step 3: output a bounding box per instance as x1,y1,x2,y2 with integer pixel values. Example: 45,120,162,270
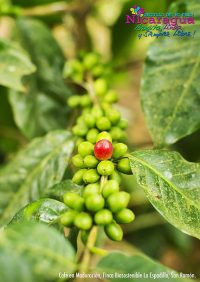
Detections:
141,0,200,145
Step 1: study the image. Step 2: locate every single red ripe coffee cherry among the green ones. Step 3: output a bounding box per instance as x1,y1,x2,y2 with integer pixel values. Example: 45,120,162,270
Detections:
94,139,113,161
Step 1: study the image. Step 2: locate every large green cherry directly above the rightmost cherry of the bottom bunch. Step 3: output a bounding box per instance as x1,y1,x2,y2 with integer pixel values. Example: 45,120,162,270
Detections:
107,191,130,212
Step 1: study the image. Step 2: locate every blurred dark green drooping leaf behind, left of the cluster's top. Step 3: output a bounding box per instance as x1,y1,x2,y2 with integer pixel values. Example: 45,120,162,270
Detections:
9,18,71,138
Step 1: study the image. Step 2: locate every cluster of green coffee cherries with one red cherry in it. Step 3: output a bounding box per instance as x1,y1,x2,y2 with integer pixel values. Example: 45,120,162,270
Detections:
60,54,135,241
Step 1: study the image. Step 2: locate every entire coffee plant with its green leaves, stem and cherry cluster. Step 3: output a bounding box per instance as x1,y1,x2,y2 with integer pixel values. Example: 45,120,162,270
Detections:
0,0,200,282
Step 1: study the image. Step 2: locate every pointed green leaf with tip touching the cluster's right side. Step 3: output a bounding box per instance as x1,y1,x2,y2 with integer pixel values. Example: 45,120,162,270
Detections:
130,150,200,239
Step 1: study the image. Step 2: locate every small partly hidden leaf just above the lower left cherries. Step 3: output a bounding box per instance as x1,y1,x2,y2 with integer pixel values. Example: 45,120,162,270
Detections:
44,179,81,201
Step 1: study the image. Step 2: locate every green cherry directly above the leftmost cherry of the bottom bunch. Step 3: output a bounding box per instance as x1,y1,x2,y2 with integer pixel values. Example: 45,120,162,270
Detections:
63,192,84,211
